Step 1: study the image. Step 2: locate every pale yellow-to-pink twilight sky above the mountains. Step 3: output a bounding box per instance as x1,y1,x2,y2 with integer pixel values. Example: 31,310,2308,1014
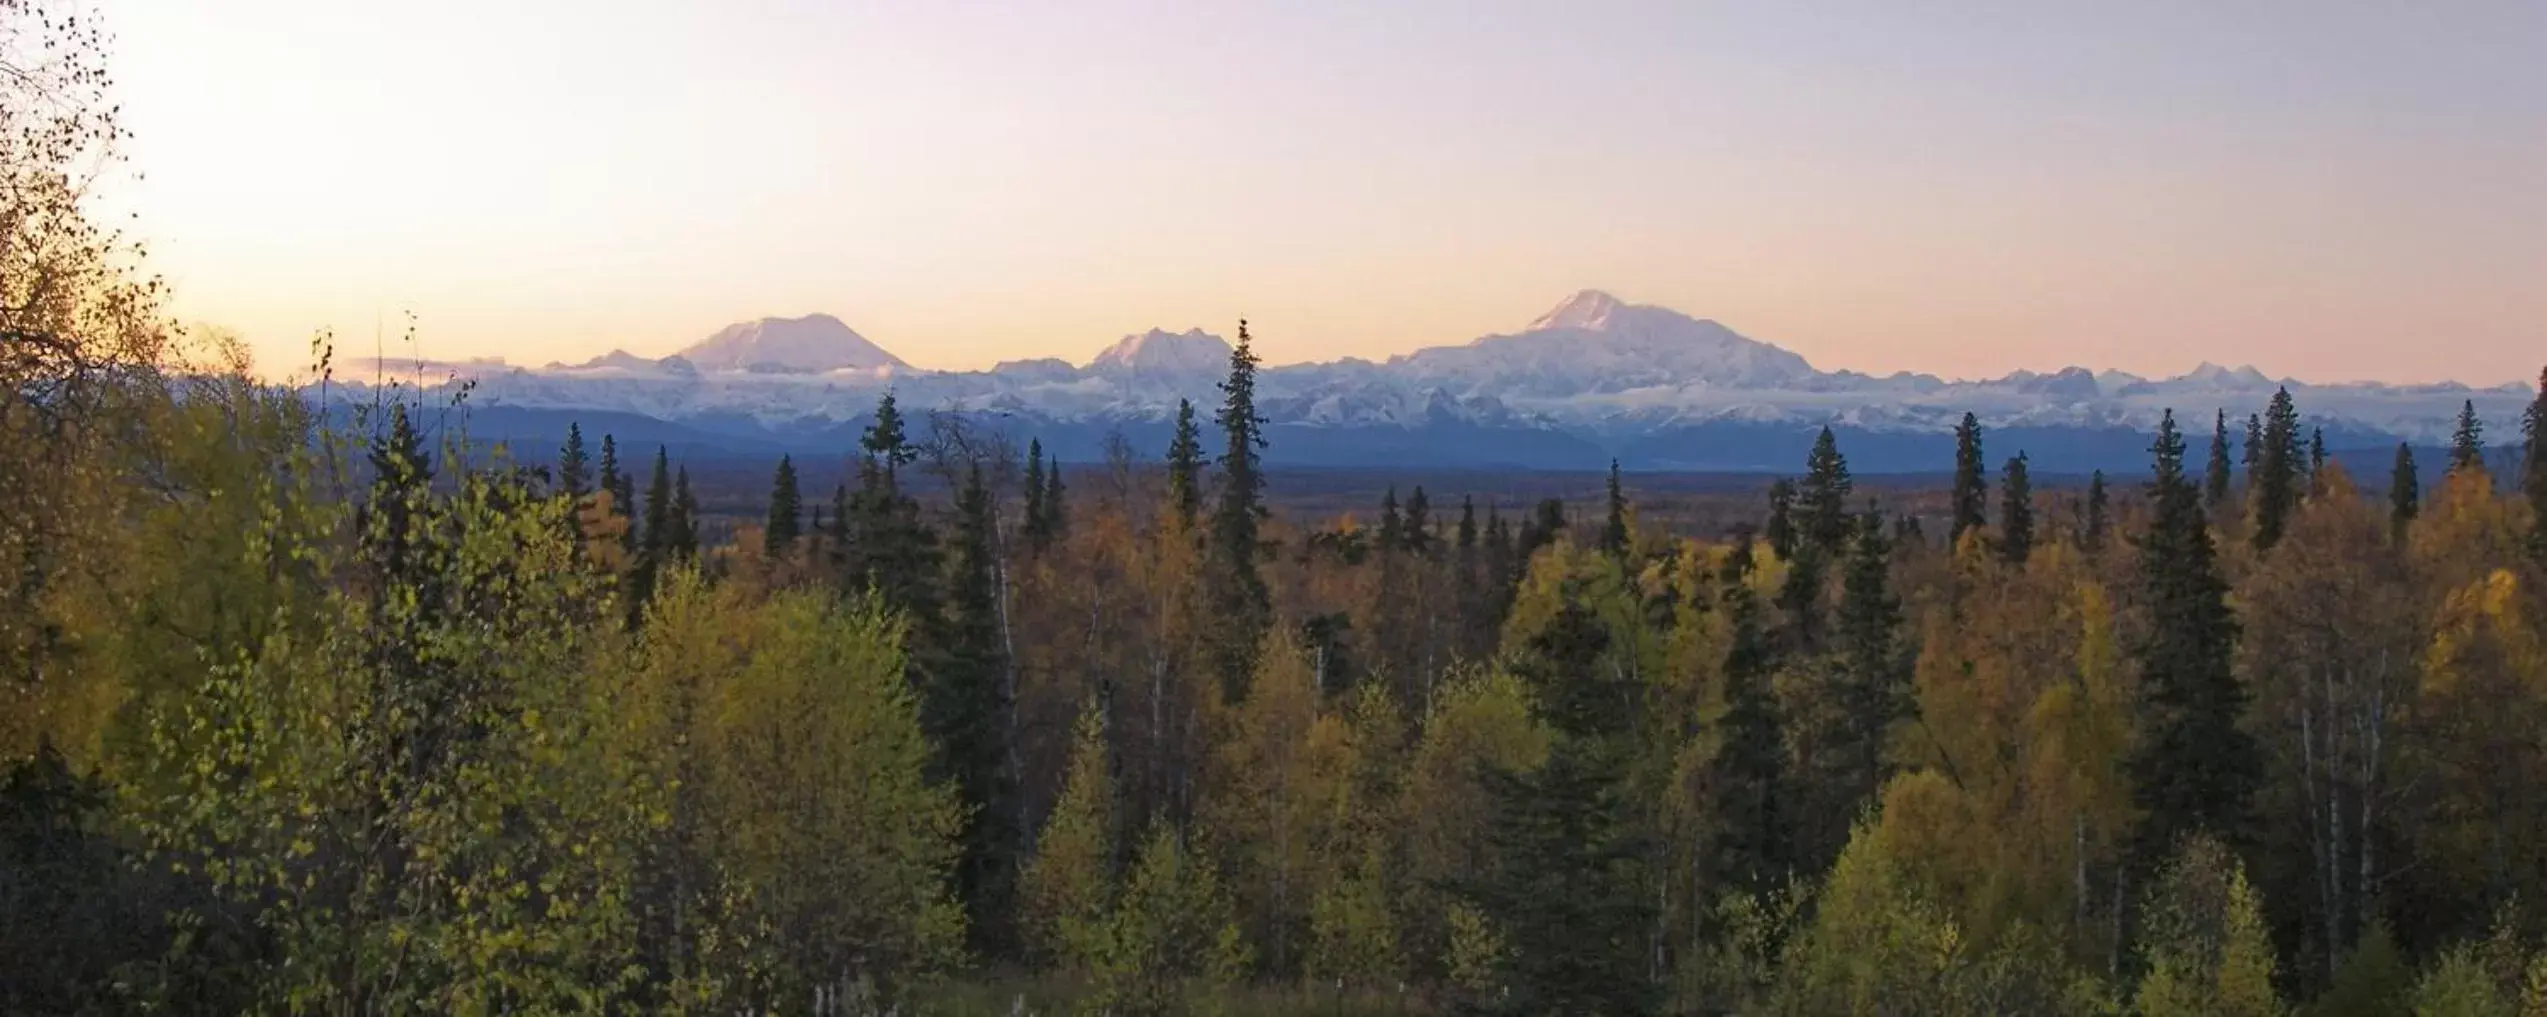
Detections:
92,0,2547,385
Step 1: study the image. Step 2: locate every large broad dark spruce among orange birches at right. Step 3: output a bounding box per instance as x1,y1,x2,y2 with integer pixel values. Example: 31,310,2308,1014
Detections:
2124,413,2272,862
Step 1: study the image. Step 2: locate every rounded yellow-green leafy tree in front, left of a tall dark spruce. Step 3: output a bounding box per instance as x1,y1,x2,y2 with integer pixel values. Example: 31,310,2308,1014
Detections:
611,568,965,1009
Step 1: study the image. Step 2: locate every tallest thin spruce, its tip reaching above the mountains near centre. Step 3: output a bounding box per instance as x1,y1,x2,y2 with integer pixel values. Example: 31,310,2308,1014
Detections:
1205,319,1271,701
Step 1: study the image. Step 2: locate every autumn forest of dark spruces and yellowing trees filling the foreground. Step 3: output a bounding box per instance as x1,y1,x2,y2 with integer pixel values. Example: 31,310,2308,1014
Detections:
14,0,2547,1017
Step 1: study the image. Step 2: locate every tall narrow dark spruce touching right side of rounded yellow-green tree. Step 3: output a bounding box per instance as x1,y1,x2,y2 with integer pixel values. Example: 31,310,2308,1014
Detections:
919,464,1021,951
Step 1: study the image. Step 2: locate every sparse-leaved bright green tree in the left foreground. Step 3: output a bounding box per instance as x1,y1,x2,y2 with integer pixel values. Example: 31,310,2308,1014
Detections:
132,435,644,1012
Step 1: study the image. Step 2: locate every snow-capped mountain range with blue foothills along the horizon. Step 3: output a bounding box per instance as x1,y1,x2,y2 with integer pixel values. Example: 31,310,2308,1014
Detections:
331,291,2532,472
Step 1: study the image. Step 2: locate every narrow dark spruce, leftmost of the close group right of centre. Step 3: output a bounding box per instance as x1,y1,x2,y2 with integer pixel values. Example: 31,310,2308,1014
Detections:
1701,533,1793,895
